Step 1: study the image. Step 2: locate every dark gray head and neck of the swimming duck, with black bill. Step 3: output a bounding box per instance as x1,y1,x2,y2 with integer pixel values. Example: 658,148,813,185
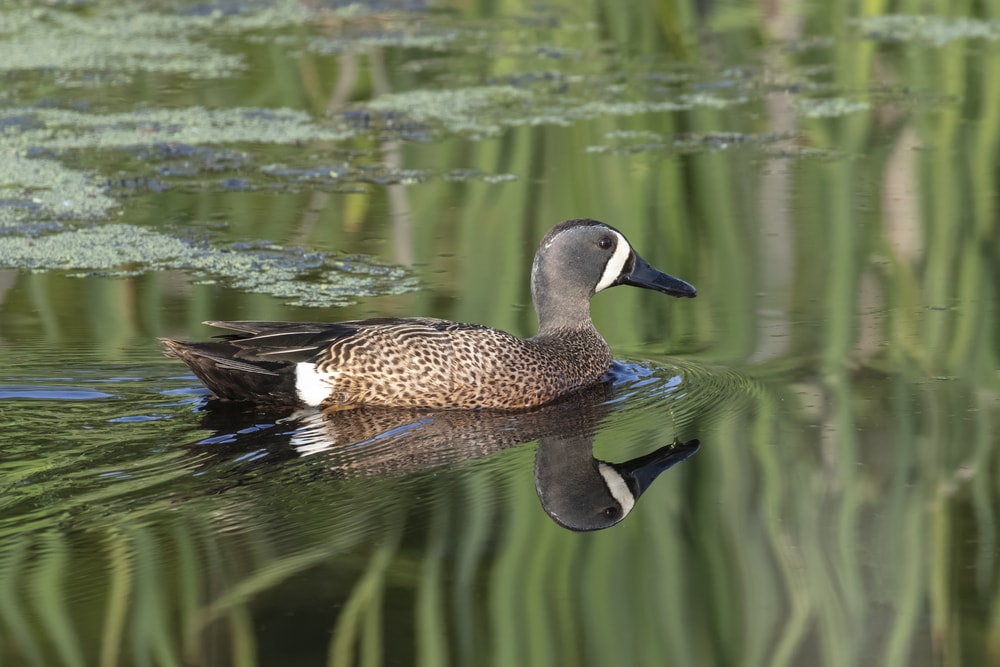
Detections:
531,218,696,331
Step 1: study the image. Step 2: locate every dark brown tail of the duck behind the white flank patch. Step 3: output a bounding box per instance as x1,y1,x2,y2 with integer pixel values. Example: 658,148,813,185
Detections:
160,338,302,406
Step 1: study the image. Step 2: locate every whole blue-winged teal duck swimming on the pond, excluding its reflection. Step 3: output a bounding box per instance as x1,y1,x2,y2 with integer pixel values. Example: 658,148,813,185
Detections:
163,219,695,410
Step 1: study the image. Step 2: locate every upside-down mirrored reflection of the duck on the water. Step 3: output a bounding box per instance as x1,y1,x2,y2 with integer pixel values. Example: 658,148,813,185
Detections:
193,384,699,531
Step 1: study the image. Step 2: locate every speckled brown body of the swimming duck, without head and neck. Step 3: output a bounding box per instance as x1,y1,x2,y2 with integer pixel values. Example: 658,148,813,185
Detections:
165,317,612,409
